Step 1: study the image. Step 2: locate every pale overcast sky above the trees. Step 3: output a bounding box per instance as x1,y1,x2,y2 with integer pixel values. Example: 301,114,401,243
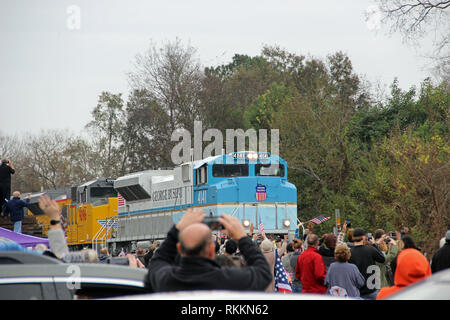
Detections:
0,0,438,135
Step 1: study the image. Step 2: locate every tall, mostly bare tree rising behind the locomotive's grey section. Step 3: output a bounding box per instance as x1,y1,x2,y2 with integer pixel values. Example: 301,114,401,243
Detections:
126,39,203,167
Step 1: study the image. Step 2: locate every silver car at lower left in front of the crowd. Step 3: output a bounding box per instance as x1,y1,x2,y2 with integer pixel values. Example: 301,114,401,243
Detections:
0,263,148,300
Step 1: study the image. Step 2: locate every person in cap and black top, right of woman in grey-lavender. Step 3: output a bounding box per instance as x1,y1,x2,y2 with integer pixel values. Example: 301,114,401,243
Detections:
349,228,386,300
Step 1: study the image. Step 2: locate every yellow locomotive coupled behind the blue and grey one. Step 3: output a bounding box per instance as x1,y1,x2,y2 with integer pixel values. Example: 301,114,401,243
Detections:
28,178,118,249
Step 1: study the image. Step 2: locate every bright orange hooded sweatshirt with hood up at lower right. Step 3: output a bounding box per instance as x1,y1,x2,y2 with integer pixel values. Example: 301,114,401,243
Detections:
377,249,431,300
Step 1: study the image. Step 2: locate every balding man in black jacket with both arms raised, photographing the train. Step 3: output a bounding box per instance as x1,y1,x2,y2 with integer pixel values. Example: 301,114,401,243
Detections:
147,209,272,292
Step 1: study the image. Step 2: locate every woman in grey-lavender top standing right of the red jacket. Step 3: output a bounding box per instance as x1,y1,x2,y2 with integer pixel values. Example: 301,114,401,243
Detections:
325,243,365,298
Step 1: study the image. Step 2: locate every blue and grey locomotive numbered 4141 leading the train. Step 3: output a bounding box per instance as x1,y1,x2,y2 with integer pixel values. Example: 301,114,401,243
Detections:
105,151,297,249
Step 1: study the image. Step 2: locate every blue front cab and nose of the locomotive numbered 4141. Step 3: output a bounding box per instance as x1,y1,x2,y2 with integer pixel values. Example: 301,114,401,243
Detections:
193,153,297,234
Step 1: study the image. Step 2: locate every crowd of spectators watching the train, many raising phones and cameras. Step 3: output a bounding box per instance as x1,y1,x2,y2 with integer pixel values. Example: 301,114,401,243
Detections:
0,161,450,300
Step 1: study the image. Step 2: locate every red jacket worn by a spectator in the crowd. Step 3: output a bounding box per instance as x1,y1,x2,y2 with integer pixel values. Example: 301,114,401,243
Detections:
295,247,327,294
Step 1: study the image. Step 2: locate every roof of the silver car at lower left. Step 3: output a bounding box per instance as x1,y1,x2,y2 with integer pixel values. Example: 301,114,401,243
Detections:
0,263,148,281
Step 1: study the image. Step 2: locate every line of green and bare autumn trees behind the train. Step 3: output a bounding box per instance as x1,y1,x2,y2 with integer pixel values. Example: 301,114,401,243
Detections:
0,40,450,254
